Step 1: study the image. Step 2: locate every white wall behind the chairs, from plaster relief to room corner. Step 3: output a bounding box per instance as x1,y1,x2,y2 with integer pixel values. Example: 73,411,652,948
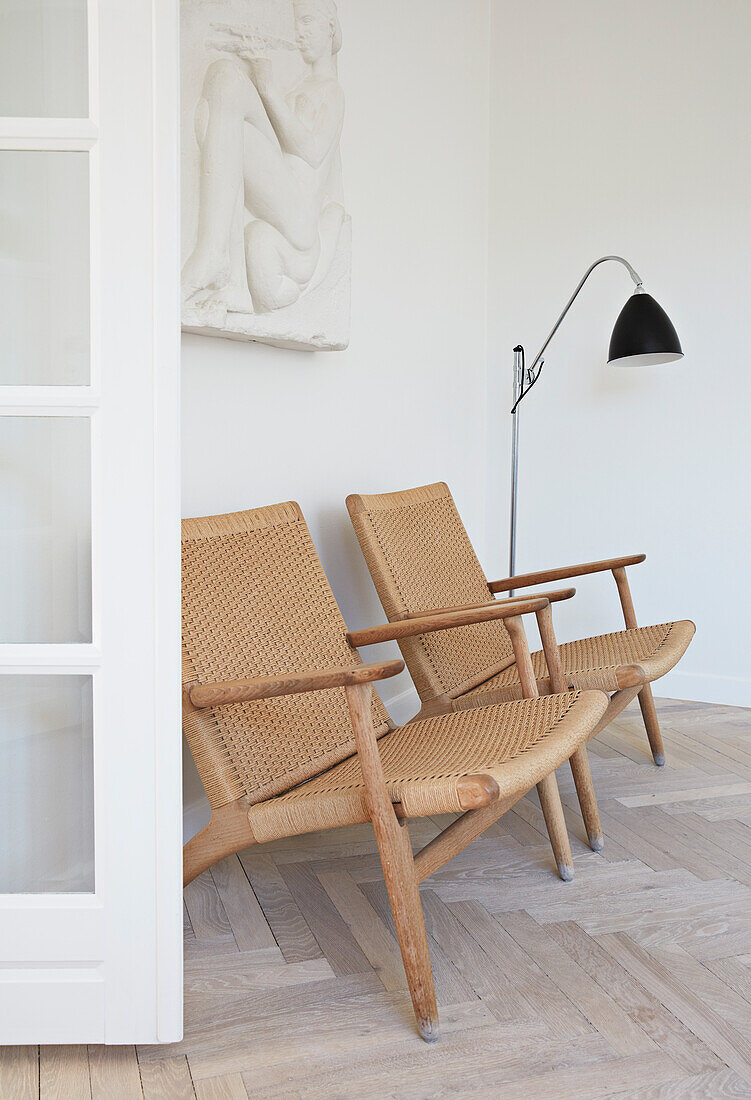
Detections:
183,0,489,831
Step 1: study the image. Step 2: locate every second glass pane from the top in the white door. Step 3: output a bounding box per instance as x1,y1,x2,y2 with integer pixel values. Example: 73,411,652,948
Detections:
0,150,89,386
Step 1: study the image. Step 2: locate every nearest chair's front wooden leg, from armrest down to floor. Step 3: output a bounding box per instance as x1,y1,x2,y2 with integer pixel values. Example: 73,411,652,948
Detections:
344,683,438,1043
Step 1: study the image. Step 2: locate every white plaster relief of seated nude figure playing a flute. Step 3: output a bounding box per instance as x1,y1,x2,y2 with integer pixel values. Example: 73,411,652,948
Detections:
181,0,351,350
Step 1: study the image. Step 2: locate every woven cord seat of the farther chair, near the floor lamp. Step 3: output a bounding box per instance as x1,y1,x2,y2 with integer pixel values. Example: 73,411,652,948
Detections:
464,619,695,706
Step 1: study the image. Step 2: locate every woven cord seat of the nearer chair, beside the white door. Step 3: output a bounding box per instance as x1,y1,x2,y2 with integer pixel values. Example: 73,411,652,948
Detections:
249,692,607,842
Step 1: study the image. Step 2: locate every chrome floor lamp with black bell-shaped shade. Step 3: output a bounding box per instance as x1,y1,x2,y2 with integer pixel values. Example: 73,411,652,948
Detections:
508,256,683,595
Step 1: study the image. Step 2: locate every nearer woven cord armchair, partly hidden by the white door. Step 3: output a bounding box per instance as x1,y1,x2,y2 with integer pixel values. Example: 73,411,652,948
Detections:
183,504,607,1040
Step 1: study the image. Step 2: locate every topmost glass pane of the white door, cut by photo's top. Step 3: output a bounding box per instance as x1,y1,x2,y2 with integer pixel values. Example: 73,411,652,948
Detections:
0,0,89,118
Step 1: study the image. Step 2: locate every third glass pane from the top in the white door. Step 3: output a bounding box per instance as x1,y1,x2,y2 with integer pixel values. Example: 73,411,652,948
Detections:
0,416,91,642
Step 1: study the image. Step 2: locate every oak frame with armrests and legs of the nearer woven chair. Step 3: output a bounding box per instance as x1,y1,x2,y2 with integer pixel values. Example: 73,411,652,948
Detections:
183,506,606,1042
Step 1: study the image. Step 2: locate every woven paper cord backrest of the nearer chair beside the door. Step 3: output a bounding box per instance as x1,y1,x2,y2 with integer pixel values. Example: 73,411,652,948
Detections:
183,504,391,807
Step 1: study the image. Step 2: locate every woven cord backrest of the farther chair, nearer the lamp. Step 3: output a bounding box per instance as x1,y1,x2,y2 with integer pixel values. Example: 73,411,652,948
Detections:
347,483,513,700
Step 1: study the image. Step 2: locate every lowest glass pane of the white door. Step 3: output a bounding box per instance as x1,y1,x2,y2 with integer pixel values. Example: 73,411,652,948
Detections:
0,674,93,893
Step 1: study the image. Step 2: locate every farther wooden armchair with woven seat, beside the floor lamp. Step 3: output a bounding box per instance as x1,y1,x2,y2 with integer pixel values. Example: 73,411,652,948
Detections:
346,482,695,778
